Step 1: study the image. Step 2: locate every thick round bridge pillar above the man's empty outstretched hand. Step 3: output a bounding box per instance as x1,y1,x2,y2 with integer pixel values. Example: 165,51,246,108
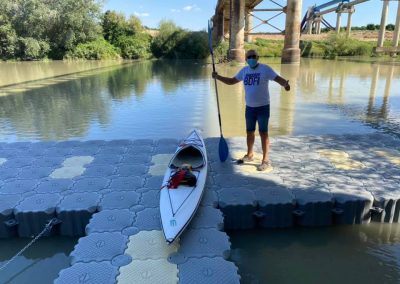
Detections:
281,0,302,64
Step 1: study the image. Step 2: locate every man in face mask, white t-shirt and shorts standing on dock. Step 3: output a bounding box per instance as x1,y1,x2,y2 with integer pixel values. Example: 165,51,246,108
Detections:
212,49,290,171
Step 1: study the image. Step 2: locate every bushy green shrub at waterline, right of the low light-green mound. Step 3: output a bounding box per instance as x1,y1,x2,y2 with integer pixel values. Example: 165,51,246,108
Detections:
116,33,151,59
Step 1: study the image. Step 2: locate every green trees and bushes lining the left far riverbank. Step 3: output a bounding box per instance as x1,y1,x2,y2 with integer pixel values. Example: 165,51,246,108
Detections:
0,0,208,60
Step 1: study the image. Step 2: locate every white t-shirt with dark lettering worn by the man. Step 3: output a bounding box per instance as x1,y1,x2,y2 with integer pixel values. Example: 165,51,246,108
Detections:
235,63,277,107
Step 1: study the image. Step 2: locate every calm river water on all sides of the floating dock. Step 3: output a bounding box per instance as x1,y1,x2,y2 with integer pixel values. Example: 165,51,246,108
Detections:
0,59,400,283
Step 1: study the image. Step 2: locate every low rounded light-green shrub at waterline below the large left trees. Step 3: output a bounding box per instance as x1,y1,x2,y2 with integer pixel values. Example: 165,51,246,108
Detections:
64,38,120,60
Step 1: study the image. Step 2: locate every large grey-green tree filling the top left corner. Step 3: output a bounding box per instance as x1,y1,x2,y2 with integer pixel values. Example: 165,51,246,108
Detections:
0,0,102,59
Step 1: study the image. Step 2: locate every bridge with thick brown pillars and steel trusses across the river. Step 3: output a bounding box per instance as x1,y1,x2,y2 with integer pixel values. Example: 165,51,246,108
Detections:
213,0,400,63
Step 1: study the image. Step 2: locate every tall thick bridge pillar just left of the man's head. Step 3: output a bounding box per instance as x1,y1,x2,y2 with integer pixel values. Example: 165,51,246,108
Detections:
229,0,245,62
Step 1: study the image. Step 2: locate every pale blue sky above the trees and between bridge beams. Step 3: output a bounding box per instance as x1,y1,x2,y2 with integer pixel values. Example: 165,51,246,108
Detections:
103,0,400,32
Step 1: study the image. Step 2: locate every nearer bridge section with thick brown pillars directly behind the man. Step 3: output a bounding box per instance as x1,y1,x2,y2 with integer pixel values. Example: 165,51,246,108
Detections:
212,0,302,63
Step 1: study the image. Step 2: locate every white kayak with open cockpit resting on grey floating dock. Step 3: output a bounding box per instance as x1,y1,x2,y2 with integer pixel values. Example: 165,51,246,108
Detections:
160,130,207,244
